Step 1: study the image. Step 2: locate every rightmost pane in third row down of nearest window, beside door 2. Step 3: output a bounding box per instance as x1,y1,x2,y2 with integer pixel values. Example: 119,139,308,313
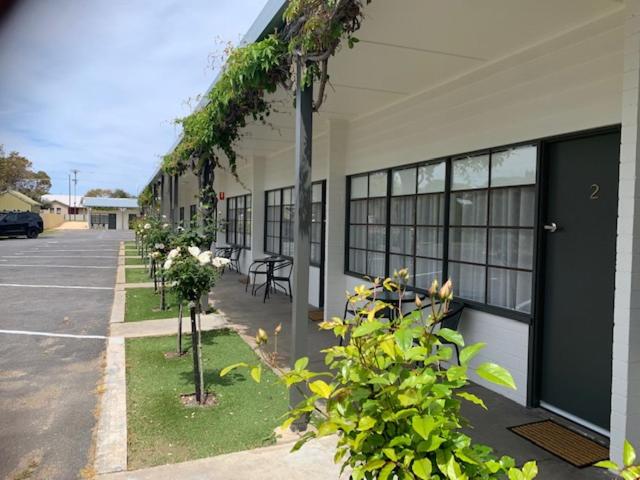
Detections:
489,228,533,269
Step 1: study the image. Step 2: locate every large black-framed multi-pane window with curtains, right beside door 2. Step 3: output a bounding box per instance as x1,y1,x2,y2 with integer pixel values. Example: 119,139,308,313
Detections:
346,145,537,314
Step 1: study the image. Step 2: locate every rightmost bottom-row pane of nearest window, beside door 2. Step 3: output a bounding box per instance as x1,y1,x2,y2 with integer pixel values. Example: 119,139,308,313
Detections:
487,268,532,313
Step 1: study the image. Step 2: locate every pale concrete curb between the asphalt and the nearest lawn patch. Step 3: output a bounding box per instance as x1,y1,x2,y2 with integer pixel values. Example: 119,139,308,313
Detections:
94,337,127,474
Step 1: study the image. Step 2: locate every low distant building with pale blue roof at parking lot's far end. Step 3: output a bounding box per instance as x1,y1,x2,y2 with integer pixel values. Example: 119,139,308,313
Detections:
82,197,140,230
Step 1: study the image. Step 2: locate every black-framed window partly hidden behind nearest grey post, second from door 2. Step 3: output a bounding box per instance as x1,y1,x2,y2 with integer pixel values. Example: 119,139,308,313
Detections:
264,181,325,266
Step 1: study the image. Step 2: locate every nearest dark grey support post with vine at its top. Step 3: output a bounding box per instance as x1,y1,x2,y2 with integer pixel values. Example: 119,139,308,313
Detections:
289,59,313,420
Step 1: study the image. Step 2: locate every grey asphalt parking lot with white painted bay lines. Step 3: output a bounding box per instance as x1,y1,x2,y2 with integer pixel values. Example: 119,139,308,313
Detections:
0,230,132,479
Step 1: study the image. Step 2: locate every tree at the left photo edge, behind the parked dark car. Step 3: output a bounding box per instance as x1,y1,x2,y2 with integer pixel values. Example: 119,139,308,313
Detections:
0,145,51,201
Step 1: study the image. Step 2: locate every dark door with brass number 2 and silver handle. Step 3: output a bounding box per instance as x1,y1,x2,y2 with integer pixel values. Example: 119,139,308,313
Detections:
539,132,620,430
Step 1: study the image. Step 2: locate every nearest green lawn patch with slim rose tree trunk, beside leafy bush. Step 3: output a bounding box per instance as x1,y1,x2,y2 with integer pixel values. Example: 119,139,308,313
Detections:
126,330,288,470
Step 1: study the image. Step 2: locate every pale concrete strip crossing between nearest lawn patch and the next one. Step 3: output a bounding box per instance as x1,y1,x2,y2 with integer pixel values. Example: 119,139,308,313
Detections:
111,313,229,338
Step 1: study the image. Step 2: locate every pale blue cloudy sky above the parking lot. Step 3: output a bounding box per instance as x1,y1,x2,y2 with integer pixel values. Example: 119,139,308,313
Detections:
0,0,266,194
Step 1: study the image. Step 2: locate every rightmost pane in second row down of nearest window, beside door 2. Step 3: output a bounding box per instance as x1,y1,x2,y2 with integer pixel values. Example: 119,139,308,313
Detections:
491,187,536,227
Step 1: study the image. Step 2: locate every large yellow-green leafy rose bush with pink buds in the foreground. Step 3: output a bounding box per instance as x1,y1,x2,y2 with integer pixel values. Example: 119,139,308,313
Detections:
221,270,538,480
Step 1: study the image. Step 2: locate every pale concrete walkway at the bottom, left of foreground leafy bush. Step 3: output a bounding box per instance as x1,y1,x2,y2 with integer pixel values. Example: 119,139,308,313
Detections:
98,436,348,480
